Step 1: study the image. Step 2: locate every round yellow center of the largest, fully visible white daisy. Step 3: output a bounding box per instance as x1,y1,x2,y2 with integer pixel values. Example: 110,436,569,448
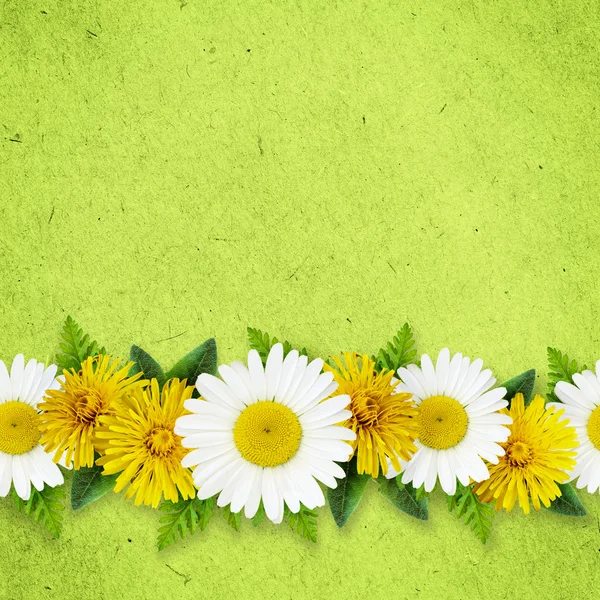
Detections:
233,400,302,467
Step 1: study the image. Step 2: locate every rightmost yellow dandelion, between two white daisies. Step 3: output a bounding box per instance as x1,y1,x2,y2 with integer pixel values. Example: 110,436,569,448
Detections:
474,394,577,514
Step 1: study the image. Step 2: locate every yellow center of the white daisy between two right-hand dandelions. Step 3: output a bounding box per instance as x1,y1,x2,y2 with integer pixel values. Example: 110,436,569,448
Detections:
419,396,469,450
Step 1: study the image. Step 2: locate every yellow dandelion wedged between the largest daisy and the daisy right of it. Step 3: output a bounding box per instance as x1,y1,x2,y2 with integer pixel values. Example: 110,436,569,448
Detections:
324,352,418,477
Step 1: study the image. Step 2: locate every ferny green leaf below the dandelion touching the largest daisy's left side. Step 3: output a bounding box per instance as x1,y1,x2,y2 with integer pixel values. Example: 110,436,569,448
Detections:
157,498,214,550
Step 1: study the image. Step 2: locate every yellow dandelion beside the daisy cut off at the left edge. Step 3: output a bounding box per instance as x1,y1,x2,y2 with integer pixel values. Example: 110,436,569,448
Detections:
38,354,148,470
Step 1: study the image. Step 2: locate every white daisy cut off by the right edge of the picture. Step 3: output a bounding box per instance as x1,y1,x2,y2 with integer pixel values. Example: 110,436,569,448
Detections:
548,360,600,494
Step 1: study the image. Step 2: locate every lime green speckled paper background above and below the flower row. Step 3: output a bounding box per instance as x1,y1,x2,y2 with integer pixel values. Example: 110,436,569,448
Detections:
0,0,600,600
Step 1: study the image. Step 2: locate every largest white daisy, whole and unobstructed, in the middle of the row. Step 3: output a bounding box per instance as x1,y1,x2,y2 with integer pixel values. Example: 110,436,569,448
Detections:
175,344,355,523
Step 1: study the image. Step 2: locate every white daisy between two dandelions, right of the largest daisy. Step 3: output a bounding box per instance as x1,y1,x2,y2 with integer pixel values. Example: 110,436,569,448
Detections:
387,348,512,495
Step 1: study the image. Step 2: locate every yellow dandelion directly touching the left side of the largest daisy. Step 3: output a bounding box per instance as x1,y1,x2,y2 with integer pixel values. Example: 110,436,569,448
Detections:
96,379,196,508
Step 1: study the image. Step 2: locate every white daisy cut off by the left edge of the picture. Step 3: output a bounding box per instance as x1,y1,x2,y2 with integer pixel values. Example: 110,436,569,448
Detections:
0,354,64,500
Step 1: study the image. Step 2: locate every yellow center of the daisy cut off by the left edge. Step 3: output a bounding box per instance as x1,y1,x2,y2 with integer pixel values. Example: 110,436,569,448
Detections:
0,400,40,454
